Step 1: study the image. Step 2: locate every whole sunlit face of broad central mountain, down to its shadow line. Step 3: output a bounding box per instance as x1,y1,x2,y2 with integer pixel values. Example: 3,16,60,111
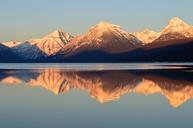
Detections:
59,22,142,56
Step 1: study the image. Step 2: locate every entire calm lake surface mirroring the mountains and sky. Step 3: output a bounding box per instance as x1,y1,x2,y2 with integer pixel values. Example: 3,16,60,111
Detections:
0,63,193,128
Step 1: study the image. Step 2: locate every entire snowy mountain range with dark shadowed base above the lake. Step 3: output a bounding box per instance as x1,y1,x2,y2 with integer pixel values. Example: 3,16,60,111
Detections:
0,17,193,62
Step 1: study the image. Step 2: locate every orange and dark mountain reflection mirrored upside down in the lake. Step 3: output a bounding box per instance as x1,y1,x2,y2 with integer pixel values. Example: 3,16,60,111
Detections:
0,68,193,108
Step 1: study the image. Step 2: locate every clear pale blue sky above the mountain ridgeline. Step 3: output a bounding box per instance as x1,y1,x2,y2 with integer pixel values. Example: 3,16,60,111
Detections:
0,0,193,42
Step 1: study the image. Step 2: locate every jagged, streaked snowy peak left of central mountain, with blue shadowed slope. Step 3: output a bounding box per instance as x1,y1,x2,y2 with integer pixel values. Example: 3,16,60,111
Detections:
13,30,72,60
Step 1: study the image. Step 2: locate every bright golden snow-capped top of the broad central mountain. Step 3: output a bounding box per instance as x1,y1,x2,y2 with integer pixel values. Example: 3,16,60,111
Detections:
82,21,141,45
